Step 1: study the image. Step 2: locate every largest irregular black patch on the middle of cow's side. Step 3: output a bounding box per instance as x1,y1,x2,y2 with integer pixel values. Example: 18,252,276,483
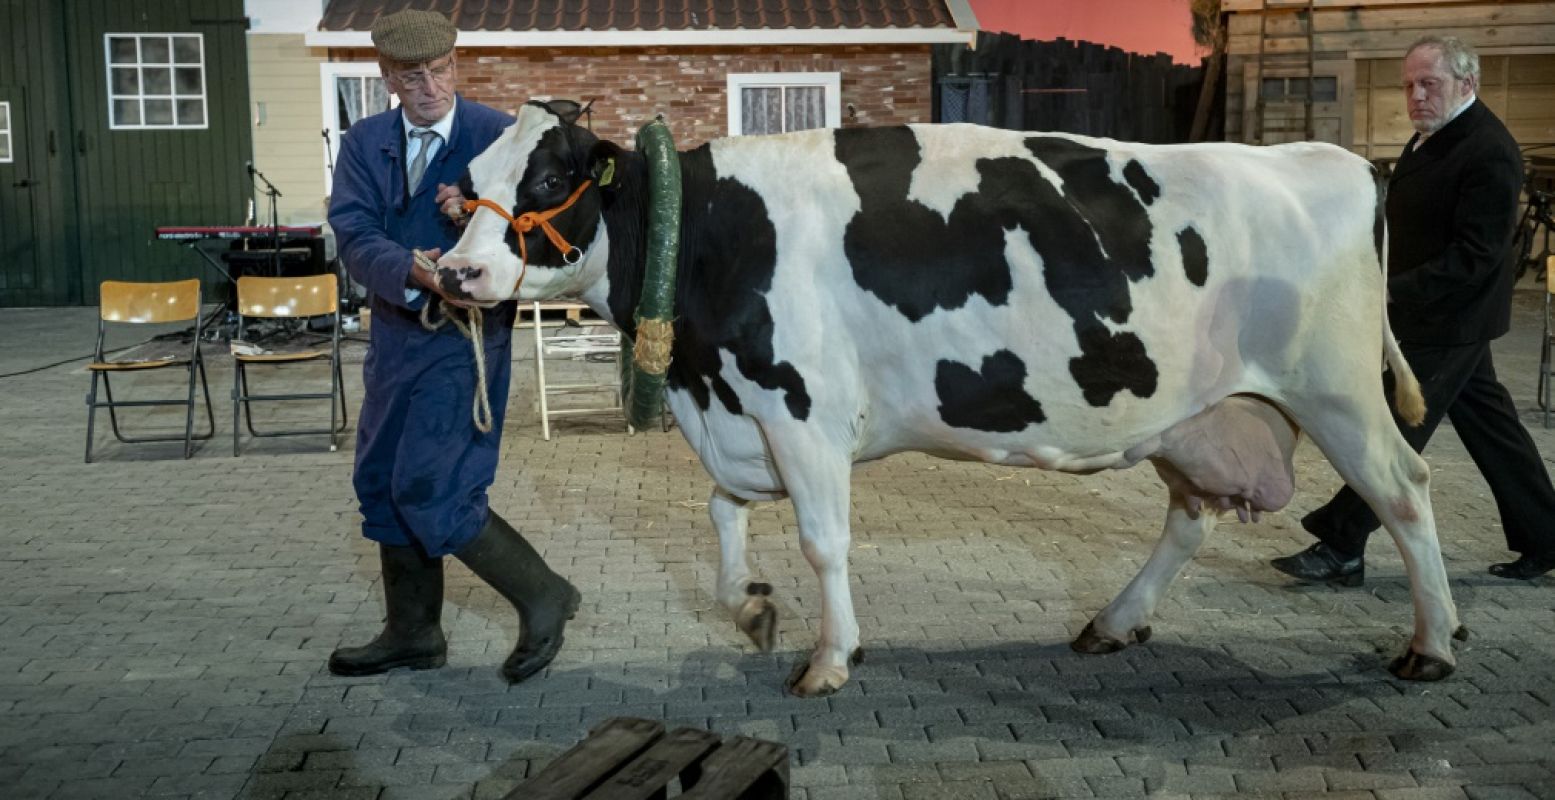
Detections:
835,128,1160,405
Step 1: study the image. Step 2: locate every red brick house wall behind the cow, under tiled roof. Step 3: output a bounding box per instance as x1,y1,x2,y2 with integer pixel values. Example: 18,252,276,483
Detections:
413,45,933,148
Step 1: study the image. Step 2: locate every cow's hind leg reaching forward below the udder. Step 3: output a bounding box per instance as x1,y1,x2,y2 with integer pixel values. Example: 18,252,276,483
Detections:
1070,490,1218,654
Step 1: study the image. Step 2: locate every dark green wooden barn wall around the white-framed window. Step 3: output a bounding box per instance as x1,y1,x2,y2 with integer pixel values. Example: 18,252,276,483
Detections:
0,0,253,307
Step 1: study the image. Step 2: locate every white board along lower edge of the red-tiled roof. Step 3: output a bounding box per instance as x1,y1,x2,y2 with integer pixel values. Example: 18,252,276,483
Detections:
303,28,977,48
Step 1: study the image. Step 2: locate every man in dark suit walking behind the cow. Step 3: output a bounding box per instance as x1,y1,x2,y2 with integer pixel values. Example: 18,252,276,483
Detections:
1270,36,1555,587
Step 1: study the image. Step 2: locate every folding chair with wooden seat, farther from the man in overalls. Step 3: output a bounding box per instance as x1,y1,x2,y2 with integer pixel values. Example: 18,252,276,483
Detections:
87,279,216,464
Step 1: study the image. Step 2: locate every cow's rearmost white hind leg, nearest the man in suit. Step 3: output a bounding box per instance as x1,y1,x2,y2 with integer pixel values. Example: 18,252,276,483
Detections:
1288,395,1466,680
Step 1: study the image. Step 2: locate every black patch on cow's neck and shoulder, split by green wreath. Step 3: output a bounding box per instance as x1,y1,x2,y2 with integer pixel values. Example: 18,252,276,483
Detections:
605,146,810,420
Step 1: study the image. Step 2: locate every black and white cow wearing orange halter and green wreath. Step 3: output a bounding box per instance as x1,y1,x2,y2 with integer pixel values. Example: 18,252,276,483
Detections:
439,104,1459,696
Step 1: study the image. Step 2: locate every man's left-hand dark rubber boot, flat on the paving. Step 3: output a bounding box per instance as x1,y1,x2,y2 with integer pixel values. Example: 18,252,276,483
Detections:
330,545,448,675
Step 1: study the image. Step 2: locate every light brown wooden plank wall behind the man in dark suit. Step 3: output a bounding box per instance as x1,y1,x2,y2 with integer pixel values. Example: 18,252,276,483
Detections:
1222,0,1555,147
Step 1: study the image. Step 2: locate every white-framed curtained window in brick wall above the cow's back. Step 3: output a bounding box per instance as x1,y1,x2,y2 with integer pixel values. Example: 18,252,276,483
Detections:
729,72,843,135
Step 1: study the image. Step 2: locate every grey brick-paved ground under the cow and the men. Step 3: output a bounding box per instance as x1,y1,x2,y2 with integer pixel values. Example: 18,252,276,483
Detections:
0,283,1555,800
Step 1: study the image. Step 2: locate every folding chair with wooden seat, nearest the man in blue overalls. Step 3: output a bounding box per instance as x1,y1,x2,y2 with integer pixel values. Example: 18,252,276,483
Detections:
232,274,348,456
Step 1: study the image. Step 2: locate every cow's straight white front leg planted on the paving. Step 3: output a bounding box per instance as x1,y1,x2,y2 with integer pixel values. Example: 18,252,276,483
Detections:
765,428,861,697
